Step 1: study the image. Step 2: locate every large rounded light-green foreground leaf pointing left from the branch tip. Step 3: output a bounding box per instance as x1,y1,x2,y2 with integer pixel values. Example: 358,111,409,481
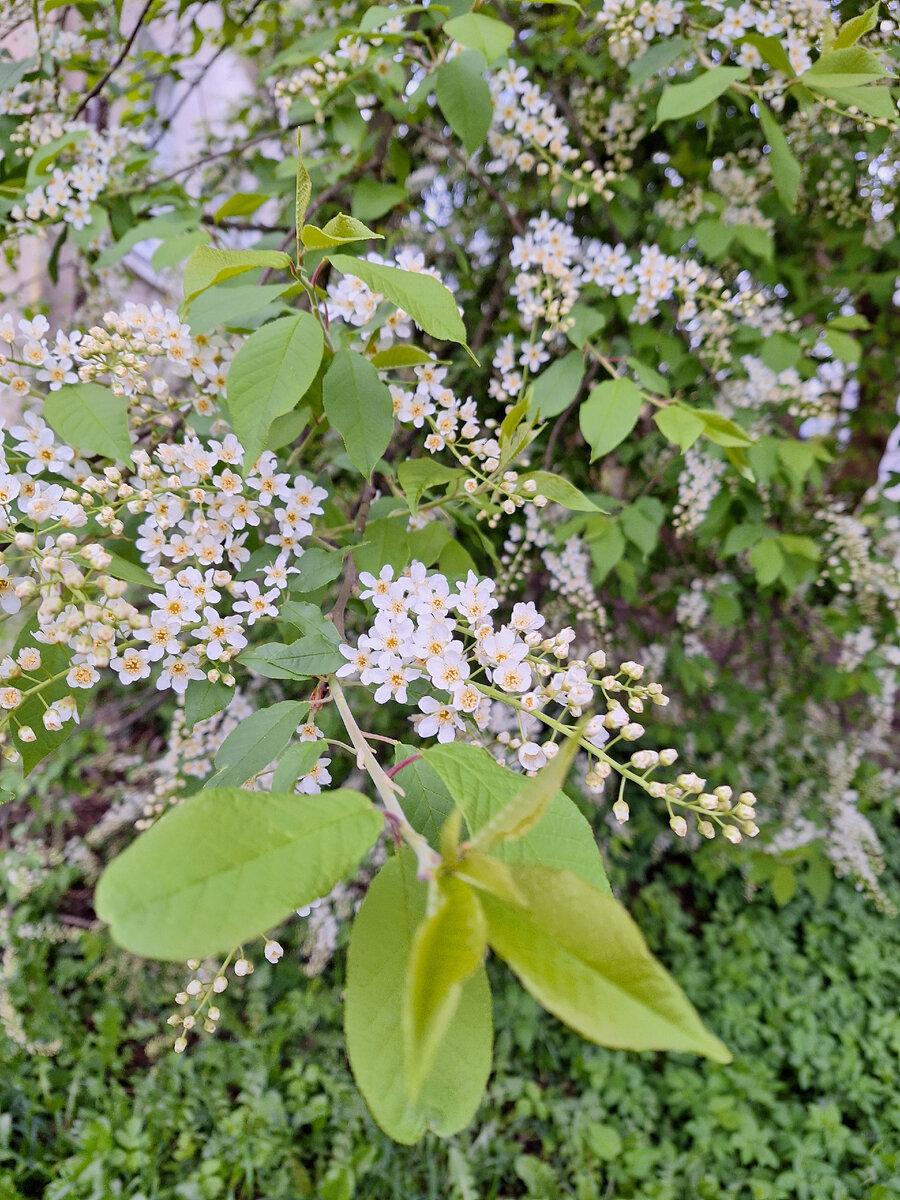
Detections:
96,787,383,962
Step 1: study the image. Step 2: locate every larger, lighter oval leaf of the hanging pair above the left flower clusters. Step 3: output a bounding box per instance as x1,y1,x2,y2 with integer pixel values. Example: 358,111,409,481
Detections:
226,312,324,466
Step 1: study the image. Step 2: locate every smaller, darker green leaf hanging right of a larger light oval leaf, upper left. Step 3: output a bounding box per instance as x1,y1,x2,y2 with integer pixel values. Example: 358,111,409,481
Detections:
322,350,394,479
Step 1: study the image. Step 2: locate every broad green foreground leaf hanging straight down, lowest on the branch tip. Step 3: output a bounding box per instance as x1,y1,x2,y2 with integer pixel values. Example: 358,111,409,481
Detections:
344,850,493,1146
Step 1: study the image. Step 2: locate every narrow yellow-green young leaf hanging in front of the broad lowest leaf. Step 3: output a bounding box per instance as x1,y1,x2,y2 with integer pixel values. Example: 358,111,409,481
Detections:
402,876,487,1100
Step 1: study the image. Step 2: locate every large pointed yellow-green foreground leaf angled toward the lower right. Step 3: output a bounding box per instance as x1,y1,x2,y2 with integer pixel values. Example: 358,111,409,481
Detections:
481,863,731,1062
